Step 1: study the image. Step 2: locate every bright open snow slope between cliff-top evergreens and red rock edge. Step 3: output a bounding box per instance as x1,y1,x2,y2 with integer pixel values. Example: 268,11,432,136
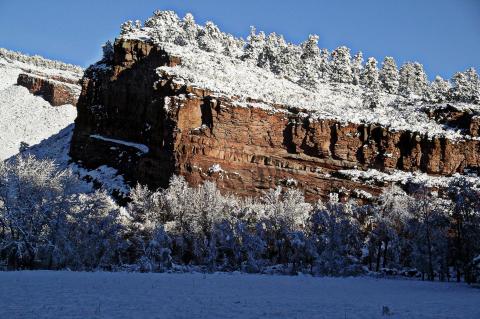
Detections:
159,43,472,139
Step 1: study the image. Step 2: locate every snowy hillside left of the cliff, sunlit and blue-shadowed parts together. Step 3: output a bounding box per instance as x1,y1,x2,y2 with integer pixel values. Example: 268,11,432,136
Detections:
0,48,129,195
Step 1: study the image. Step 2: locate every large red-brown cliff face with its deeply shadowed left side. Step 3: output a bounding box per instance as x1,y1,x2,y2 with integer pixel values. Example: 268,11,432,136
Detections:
71,40,480,200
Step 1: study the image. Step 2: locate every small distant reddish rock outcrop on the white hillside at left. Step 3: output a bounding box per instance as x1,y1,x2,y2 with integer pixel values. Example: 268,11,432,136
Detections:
17,73,81,106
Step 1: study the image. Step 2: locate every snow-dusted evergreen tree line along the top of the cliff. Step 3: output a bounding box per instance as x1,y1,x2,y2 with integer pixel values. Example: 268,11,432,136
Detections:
121,11,480,107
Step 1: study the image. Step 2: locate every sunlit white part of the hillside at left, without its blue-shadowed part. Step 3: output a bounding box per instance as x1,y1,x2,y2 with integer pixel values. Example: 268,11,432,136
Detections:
0,55,80,160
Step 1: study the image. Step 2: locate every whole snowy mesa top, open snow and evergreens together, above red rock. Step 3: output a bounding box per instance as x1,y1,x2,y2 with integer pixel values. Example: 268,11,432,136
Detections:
121,11,480,139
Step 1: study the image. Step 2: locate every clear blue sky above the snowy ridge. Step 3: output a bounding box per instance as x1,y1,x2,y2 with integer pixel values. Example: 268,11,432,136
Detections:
0,0,480,79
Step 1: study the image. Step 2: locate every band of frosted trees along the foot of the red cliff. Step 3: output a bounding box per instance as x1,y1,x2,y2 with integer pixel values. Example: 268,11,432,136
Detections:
0,156,480,282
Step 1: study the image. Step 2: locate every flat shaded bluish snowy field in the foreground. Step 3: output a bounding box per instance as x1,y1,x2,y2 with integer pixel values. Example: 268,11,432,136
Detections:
0,271,480,319
